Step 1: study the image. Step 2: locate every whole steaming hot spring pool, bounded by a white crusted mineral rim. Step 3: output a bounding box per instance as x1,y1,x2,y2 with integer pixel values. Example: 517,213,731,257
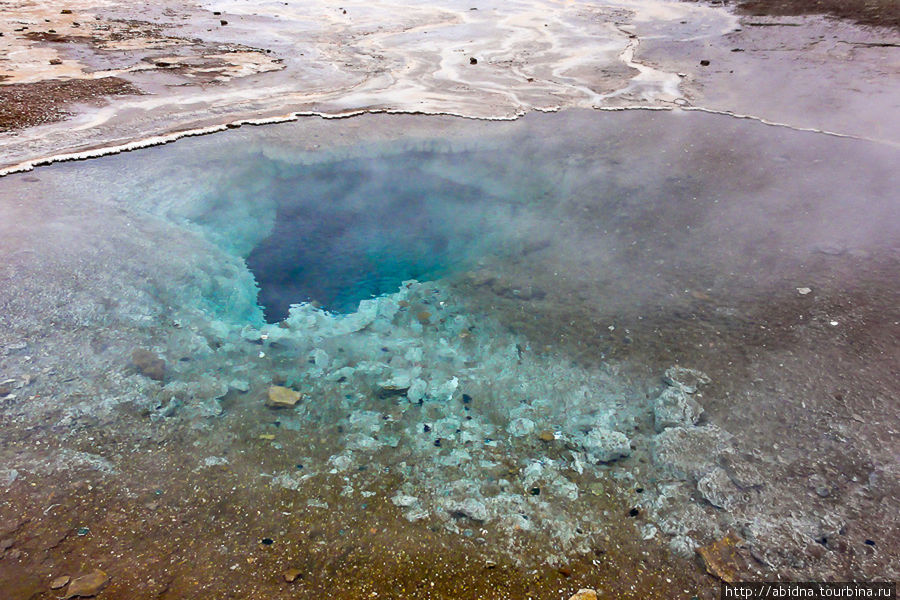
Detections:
0,111,900,597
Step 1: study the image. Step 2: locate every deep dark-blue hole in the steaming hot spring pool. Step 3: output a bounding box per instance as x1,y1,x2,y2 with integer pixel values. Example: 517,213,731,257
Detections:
246,155,496,322
